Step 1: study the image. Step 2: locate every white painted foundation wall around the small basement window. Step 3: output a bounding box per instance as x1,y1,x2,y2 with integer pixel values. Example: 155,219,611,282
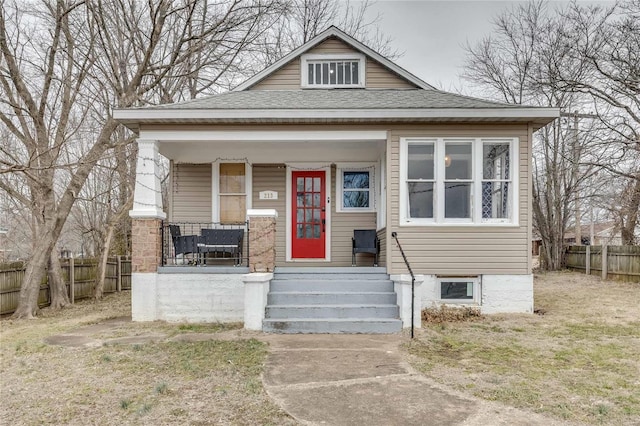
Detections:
422,275,533,314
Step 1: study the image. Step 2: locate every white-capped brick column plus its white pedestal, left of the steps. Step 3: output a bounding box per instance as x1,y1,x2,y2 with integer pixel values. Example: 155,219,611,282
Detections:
242,209,278,330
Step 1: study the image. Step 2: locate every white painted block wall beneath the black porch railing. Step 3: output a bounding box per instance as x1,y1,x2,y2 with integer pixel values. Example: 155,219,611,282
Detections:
131,273,244,322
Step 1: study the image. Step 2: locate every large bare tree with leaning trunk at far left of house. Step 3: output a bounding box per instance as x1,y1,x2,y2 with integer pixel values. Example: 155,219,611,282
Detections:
0,0,279,318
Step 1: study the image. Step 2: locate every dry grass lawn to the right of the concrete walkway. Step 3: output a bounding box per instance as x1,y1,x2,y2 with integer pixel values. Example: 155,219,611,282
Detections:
406,272,640,425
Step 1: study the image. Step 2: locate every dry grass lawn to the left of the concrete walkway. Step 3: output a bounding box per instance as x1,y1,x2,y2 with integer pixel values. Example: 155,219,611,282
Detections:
0,292,293,425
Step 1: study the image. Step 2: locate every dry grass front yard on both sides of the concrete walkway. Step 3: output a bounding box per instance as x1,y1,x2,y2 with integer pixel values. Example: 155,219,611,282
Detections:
0,272,640,425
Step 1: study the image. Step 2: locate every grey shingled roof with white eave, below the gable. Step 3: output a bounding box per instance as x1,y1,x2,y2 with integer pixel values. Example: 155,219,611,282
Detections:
114,89,559,131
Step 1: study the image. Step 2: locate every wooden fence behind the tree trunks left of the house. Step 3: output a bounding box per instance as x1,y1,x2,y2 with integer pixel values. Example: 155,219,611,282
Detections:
0,256,131,315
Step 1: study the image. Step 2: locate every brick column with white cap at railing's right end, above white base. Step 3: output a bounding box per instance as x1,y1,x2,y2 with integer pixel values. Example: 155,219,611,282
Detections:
247,209,278,272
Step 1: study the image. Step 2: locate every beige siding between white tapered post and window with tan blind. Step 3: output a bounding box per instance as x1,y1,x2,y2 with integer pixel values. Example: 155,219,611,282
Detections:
169,162,212,222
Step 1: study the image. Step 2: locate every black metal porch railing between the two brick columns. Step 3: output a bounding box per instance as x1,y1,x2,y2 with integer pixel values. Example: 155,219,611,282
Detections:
161,221,250,267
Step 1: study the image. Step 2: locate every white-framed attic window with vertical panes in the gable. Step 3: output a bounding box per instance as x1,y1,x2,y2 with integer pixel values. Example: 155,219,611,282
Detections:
301,53,365,88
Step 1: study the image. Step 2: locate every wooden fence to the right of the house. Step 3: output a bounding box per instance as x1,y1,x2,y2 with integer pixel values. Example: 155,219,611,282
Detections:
565,246,640,282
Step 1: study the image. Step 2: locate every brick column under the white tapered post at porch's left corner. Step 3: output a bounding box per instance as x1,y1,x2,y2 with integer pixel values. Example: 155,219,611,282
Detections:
131,218,162,272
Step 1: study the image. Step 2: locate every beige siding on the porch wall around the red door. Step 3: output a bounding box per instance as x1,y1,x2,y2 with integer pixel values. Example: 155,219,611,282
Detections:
253,164,376,267
